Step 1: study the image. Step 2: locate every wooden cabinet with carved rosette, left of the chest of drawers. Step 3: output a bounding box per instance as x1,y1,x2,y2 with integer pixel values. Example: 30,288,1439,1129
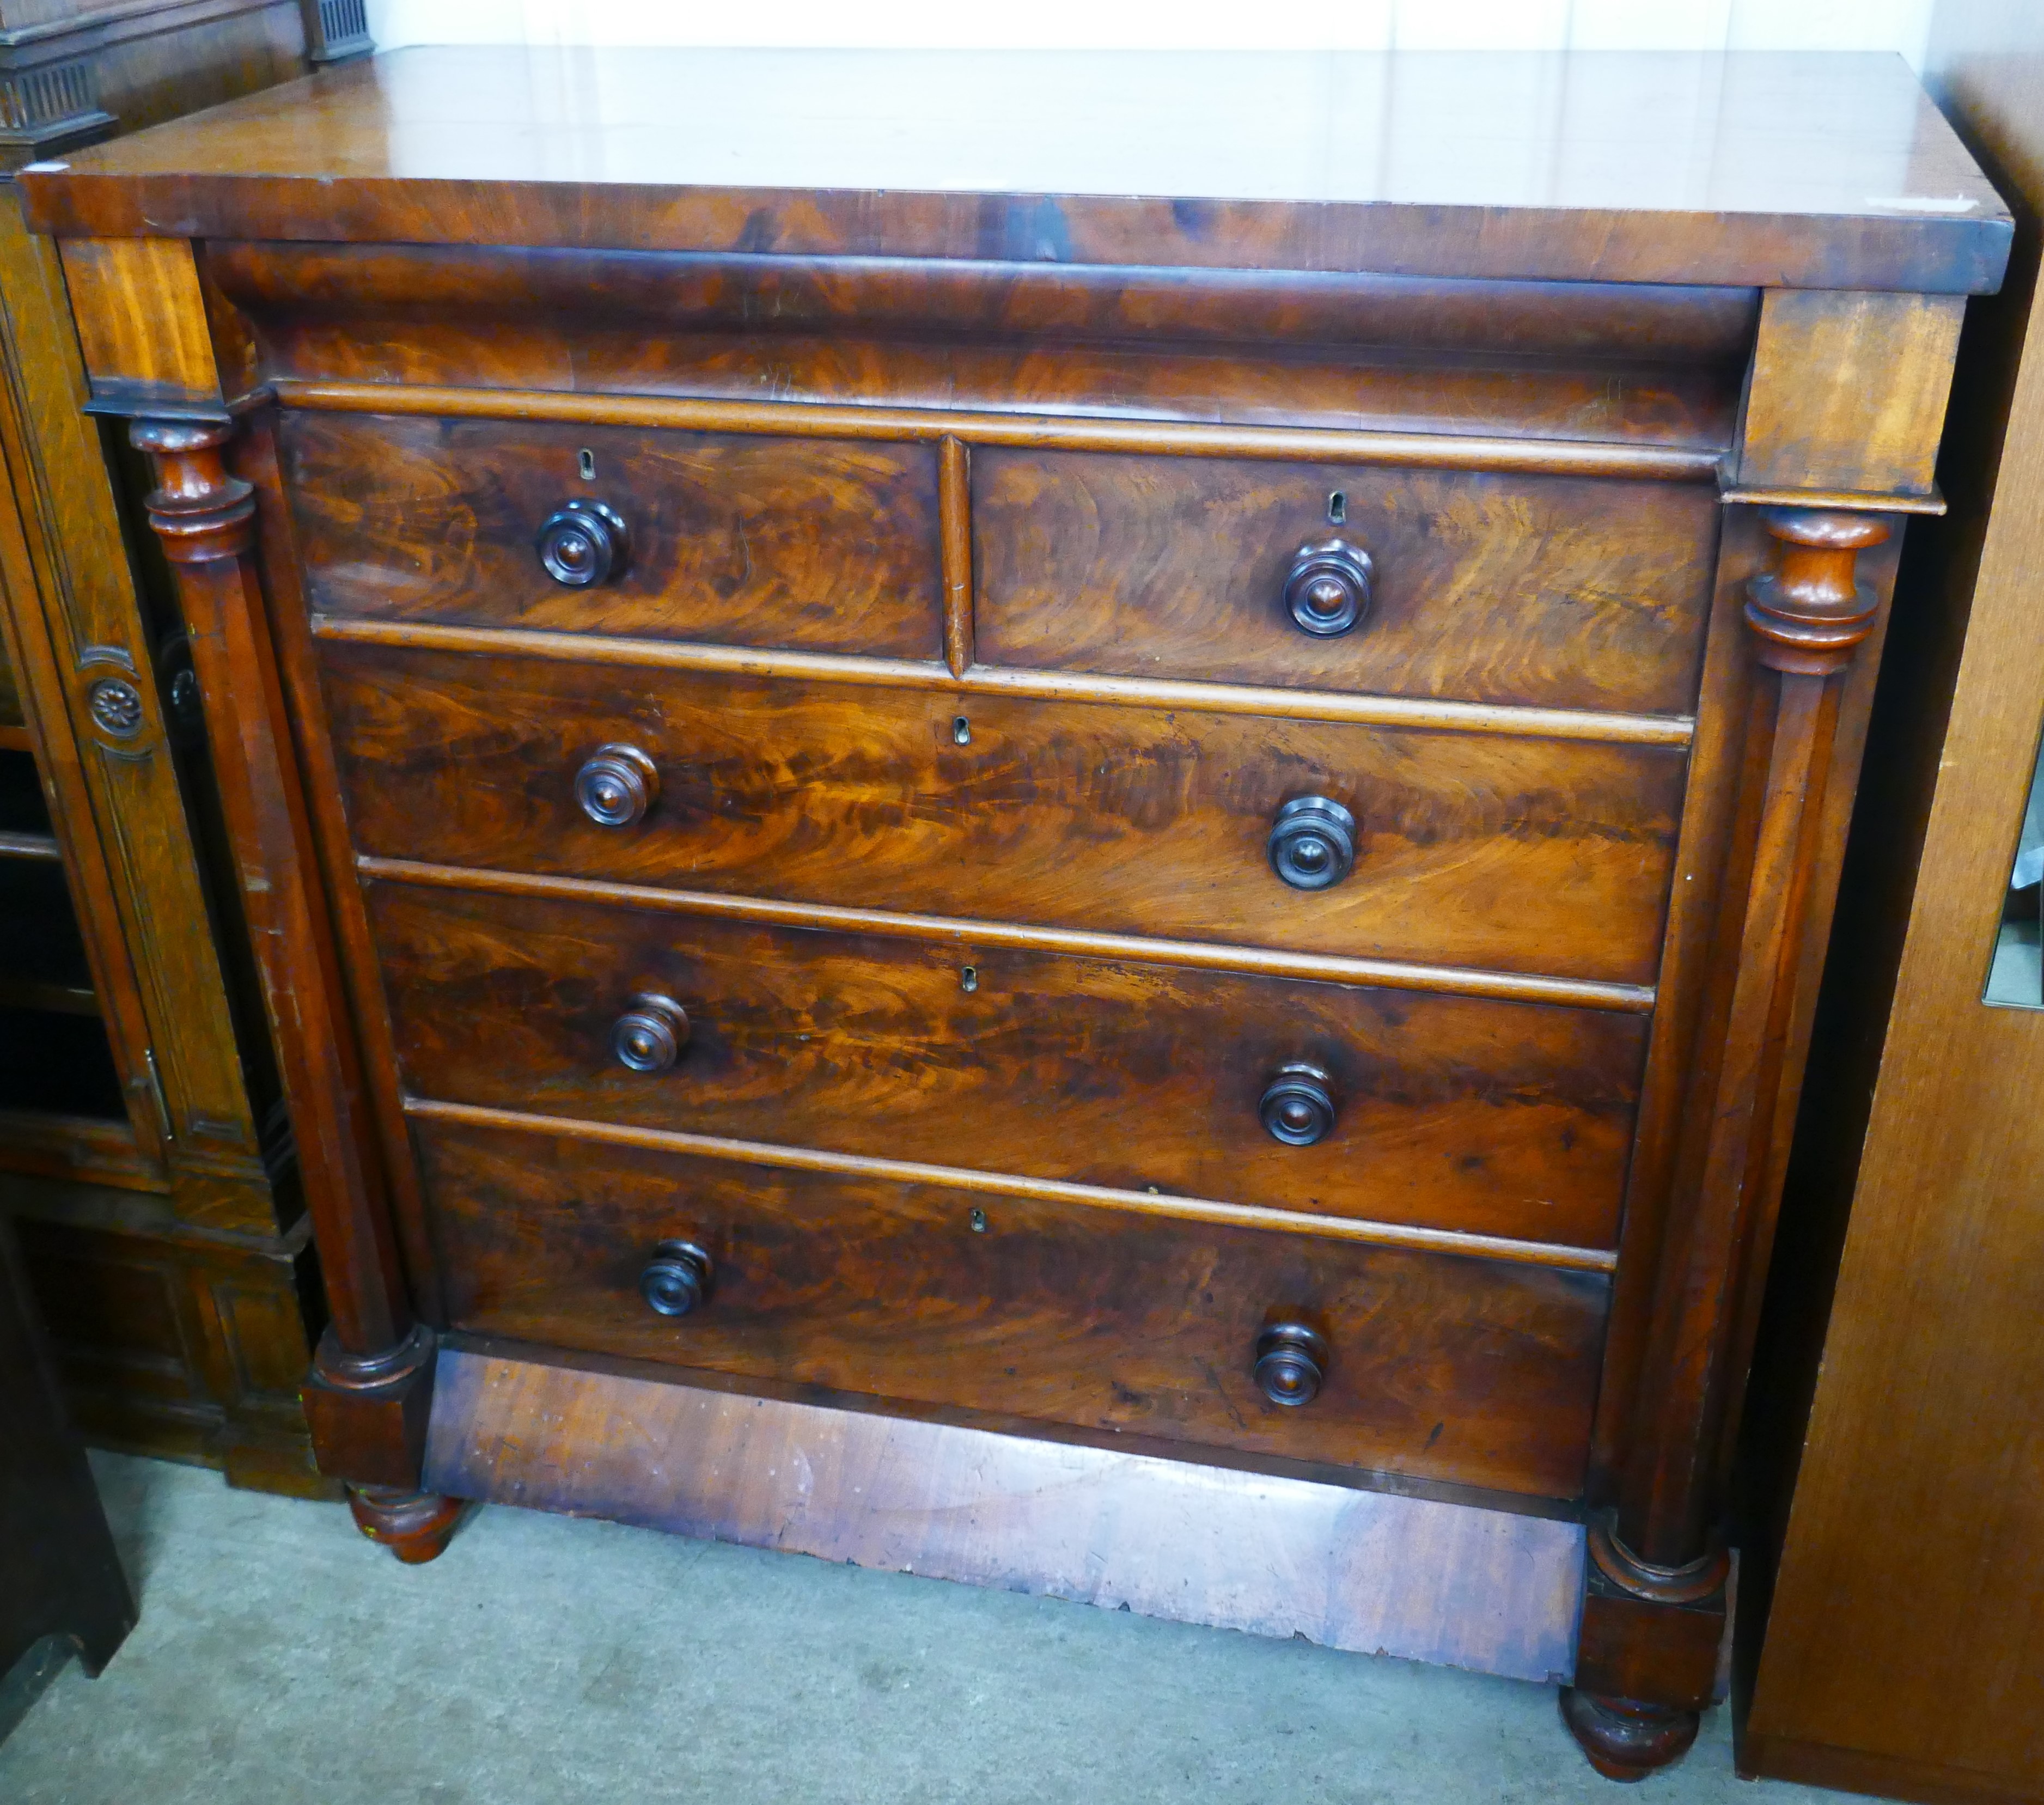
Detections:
0,0,368,1492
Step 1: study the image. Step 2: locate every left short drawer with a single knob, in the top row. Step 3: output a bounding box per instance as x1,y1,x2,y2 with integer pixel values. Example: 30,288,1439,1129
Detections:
282,411,942,660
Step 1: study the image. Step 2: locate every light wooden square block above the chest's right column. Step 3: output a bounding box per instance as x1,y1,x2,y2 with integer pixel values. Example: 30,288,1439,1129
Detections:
1740,288,1966,495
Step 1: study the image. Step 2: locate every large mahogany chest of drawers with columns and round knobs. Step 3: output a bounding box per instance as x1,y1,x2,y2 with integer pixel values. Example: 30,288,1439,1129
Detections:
27,51,2009,1776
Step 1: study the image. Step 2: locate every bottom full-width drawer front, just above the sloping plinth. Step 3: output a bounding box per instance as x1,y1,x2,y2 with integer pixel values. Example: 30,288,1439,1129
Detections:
415,1118,1609,1498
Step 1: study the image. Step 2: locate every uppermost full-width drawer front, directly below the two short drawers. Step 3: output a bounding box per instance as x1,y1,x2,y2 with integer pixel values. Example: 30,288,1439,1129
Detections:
323,640,1684,983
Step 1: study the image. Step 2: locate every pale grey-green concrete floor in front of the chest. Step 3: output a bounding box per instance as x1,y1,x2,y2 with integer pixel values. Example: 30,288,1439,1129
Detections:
0,1458,1844,1805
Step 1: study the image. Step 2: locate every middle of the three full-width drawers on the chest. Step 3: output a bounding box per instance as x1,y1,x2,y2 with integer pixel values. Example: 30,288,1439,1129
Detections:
370,883,1648,1247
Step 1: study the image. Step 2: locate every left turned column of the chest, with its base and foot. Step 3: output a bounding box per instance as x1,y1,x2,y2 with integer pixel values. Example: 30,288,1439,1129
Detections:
131,419,456,1560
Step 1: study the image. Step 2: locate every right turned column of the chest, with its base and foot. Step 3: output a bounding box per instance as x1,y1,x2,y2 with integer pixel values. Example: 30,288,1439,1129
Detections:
1561,507,1889,1780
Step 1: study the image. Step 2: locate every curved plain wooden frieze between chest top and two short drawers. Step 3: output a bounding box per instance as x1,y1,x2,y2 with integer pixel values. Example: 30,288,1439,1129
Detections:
204,243,1758,450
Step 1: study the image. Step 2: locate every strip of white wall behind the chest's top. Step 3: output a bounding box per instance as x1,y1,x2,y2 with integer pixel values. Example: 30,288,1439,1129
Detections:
368,0,1933,65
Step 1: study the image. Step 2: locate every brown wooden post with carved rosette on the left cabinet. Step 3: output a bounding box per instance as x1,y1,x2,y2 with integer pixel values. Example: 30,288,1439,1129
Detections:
0,187,276,1210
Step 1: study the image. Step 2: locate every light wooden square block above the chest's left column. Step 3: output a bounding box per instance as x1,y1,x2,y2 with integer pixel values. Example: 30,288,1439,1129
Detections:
59,237,221,409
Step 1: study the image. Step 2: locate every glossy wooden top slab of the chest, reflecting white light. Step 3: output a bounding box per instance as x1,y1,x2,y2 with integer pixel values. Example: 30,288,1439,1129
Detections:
8,45,2009,292
